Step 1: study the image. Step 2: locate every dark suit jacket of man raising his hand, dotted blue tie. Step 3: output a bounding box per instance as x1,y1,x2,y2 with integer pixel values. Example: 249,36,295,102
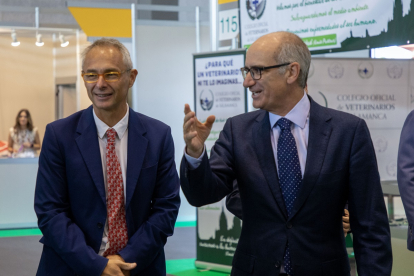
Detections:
181,99,392,276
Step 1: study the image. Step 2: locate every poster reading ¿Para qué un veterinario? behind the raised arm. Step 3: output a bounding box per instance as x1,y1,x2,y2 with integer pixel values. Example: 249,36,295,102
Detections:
194,50,246,272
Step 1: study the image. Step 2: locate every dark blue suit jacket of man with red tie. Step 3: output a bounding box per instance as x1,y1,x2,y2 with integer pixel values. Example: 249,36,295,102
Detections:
35,106,180,276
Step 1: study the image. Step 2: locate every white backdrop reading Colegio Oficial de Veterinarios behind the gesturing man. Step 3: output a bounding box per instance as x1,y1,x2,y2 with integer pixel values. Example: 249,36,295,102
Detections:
308,59,414,180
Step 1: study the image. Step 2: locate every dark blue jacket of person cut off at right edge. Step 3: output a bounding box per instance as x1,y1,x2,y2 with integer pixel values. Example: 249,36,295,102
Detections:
397,111,414,251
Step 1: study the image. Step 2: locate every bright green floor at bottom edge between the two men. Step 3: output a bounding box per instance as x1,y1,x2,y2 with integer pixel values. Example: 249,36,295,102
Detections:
166,259,229,276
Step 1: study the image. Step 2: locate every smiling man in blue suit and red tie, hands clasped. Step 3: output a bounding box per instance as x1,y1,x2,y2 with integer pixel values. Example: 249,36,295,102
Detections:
35,39,180,276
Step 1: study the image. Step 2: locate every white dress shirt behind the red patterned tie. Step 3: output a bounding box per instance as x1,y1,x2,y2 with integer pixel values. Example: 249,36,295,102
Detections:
93,104,129,256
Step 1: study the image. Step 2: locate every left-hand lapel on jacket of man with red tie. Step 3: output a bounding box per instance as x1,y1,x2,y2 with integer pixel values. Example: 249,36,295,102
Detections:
75,106,106,205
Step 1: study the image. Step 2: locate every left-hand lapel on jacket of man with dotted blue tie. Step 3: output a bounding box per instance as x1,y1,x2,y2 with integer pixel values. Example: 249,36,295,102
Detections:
253,112,287,218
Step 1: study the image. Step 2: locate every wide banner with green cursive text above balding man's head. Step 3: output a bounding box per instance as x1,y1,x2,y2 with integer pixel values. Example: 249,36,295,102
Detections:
240,0,414,52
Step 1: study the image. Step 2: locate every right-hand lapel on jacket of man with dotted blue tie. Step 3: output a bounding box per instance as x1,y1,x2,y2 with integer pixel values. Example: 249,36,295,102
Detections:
291,97,332,218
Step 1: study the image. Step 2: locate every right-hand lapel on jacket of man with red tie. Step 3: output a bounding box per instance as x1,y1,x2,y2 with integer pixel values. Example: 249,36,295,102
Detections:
125,109,148,209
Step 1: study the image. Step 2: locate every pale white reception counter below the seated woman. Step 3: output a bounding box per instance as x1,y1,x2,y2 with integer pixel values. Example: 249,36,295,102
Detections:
0,158,39,229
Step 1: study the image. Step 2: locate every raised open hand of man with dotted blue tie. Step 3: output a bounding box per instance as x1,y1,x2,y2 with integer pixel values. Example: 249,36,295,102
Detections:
183,104,216,158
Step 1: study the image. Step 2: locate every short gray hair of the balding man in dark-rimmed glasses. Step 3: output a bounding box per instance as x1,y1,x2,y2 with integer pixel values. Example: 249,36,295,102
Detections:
275,34,311,88
